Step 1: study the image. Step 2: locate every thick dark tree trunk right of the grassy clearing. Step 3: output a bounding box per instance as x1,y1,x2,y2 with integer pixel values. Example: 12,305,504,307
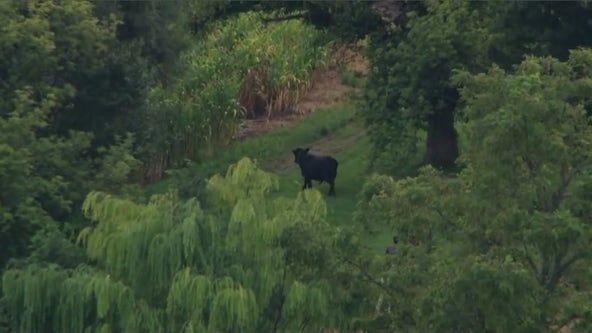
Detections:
424,109,458,167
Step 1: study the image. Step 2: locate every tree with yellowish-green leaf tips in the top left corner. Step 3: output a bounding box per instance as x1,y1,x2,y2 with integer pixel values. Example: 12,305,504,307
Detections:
0,1,137,145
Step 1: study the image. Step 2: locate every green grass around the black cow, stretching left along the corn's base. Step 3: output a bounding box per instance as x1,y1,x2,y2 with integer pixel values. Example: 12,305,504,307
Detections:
139,54,408,253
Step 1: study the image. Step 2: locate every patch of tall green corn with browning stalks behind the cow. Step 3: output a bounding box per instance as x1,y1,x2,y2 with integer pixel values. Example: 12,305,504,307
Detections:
143,13,331,182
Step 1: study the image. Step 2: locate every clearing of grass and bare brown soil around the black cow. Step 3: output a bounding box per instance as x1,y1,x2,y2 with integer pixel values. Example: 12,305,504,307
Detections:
147,44,392,252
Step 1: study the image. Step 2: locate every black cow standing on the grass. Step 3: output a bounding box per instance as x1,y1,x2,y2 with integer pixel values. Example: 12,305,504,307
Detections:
292,148,338,195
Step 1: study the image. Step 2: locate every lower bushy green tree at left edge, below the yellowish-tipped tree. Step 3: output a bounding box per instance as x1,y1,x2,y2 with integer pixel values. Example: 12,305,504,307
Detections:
0,91,91,267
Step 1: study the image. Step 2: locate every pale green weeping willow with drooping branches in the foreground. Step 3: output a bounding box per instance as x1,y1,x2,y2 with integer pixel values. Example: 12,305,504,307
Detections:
2,158,368,333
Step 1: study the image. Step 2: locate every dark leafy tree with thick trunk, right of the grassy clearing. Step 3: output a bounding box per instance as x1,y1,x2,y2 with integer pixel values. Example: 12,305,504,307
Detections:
360,1,491,173
